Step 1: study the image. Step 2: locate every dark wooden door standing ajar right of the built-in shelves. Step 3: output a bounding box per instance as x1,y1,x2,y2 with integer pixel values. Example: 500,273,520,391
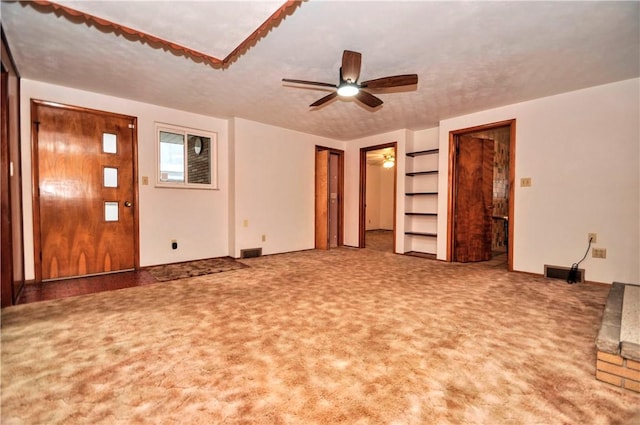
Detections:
453,137,494,263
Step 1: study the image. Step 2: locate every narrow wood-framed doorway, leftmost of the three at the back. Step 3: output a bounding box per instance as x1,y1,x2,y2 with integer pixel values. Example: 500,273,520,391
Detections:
315,146,344,249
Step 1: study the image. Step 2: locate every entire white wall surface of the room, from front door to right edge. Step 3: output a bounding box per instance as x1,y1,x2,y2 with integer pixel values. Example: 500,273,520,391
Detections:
16,79,640,282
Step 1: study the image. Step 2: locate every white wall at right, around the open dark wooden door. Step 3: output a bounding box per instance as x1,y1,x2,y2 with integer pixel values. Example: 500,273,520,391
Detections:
438,79,640,283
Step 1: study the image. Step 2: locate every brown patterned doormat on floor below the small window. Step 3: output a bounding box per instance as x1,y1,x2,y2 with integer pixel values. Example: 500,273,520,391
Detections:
146,257,249,282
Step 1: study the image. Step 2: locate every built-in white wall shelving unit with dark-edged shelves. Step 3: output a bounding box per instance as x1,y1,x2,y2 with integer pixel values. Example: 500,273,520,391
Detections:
404,149,439,258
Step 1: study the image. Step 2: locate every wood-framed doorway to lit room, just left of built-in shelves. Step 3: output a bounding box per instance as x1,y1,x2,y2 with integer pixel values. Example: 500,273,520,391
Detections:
358,142,397,252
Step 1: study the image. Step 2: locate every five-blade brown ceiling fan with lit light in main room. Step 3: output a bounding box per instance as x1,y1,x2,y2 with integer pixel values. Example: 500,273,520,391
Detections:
282,50,418,108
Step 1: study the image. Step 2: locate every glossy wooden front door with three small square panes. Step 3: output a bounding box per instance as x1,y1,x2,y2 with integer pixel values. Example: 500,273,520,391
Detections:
32,102,137,280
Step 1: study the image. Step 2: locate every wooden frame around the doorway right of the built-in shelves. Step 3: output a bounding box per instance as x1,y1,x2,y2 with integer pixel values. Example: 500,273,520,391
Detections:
446,118,516,271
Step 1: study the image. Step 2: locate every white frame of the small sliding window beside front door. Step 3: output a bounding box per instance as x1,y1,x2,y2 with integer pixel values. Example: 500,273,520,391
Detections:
155,122,219,190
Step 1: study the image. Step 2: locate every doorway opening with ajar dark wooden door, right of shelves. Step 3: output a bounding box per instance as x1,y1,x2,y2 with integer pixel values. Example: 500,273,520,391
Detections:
447,119,516,271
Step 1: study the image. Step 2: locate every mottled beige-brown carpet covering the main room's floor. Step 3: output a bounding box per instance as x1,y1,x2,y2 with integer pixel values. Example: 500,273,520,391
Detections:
1,248,640,425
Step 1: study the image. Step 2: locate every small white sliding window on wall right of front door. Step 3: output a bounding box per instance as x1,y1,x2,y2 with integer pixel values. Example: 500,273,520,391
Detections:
156,124,218,189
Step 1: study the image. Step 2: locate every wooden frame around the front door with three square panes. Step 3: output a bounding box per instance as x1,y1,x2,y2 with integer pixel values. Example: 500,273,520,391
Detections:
31,99,140,283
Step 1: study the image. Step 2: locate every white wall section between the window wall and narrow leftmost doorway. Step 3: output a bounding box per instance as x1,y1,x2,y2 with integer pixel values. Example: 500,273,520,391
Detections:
232,118,344,257
